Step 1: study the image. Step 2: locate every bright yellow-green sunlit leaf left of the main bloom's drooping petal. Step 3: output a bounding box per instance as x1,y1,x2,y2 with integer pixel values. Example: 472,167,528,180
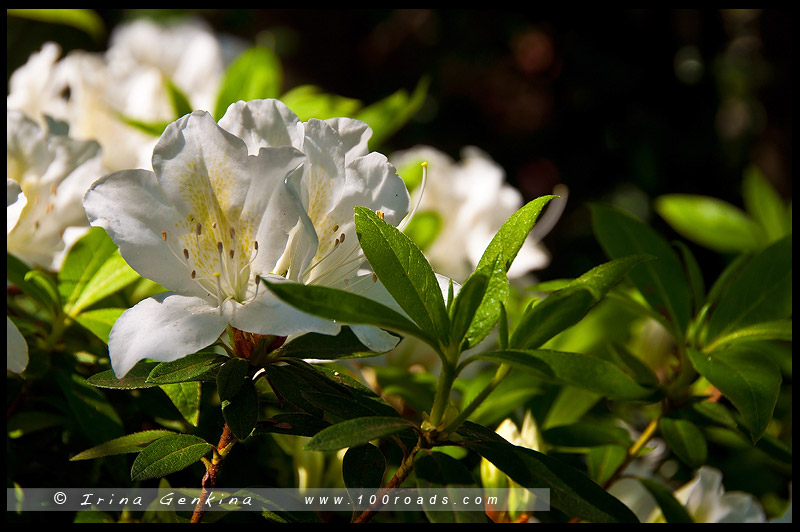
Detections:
58,227,139,317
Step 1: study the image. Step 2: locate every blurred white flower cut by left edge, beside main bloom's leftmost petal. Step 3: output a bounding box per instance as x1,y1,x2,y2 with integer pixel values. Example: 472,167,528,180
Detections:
6,110,105,271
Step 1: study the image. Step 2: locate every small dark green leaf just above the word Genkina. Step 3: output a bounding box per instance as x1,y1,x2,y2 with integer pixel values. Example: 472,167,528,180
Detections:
131,434,214,482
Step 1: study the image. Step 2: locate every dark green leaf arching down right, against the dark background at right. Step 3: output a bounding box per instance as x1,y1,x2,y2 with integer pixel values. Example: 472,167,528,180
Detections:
592,205,691,335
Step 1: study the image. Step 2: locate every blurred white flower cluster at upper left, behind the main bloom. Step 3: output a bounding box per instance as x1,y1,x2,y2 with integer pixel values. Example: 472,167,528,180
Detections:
7,20,243,171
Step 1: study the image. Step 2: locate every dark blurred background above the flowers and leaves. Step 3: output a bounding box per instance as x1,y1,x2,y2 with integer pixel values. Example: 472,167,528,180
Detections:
7,8,792,281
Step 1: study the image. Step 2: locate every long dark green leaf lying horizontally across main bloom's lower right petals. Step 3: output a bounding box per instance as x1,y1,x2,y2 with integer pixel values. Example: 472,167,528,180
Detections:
264,280,438,348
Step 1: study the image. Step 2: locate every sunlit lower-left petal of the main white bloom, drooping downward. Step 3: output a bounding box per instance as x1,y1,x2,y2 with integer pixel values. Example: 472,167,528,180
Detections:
108,292,227,378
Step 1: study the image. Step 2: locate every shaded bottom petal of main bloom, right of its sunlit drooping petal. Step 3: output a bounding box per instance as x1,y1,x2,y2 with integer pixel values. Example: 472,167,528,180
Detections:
223,275,341,336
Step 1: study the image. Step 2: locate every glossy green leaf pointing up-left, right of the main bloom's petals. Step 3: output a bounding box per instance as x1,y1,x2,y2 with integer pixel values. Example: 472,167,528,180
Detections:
355,207,450,346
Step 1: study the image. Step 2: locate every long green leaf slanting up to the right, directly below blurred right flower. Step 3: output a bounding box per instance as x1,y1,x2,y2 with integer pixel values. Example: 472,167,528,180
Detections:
509,255,648,348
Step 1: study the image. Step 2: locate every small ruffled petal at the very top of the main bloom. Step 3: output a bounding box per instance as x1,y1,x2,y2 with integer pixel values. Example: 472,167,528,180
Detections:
219,100,303,155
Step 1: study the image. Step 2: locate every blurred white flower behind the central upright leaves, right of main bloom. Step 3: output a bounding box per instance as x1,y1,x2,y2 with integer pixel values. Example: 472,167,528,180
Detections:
390,141,566,282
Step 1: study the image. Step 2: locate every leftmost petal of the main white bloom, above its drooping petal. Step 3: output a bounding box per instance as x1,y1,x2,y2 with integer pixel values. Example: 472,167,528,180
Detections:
83,170,206,297
